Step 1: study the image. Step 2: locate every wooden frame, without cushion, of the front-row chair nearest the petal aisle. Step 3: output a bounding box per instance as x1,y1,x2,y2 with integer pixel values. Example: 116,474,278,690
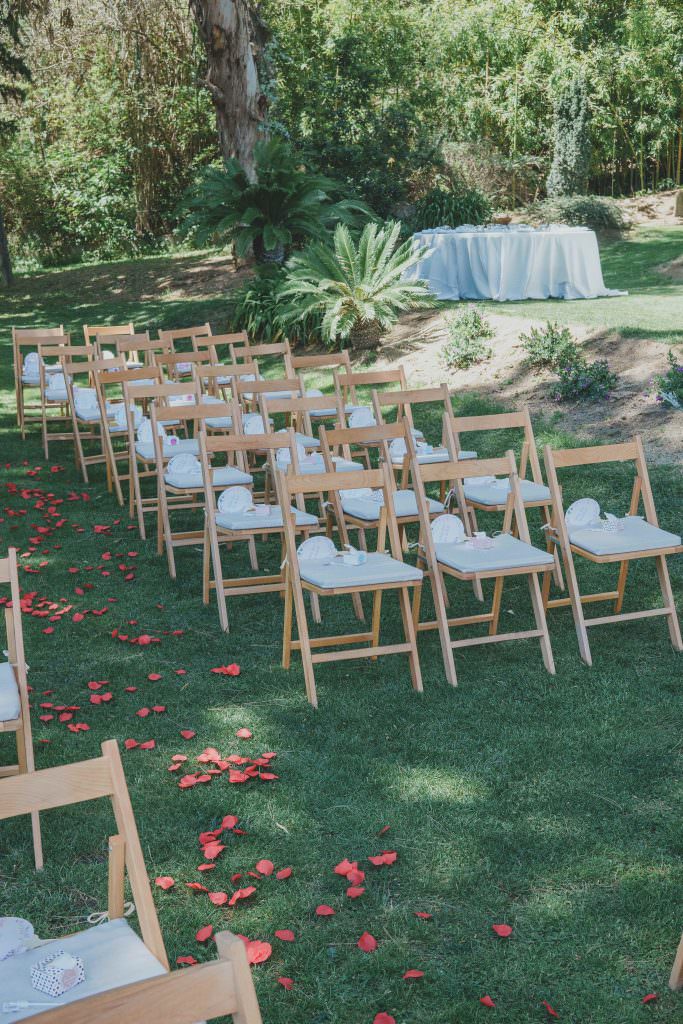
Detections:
275,464,423,708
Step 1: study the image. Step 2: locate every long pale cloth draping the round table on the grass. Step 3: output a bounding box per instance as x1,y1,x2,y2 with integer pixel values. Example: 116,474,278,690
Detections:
407,225,626,302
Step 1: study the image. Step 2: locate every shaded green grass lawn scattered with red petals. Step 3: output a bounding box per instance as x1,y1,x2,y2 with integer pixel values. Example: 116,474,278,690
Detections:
0,241,683,1024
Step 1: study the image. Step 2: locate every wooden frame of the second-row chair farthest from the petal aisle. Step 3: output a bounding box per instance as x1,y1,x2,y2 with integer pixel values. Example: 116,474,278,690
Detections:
450,406,564,590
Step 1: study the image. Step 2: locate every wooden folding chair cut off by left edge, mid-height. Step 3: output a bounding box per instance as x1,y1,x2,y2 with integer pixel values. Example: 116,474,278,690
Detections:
0,548,43,870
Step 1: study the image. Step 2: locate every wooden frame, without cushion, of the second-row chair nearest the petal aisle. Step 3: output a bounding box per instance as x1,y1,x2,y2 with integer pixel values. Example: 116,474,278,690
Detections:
200,423,317,633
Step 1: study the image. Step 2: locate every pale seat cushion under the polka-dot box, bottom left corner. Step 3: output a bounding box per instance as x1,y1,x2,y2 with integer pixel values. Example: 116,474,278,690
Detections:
0,918,166,1024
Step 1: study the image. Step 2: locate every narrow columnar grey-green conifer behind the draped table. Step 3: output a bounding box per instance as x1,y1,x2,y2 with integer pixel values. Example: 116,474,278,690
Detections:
546,75,591,197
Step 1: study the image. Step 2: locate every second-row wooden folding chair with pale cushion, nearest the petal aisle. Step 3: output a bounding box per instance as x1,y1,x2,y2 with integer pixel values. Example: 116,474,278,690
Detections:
199,425,318,633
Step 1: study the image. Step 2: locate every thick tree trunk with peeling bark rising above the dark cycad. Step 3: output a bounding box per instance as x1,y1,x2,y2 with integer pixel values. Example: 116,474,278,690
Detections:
189,0,268,179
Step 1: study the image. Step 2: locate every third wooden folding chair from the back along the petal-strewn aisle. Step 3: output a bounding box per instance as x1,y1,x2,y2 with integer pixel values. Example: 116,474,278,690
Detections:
61,345,125,490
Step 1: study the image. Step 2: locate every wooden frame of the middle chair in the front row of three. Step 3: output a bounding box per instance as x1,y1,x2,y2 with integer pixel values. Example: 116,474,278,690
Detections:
405,417,555,686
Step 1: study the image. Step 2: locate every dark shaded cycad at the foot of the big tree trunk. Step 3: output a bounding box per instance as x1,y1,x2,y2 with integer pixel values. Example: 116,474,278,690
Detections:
183,138,372,263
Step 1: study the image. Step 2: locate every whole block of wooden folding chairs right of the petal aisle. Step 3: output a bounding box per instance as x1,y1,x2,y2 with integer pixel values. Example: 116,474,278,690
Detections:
10,324,683,703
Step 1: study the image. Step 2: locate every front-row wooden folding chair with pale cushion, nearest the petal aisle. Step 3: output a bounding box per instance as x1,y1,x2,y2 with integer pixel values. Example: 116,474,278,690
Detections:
275,465,422,708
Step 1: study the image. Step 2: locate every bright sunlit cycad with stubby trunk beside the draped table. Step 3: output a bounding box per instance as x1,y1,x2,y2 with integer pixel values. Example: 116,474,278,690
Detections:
280,221,434,349
